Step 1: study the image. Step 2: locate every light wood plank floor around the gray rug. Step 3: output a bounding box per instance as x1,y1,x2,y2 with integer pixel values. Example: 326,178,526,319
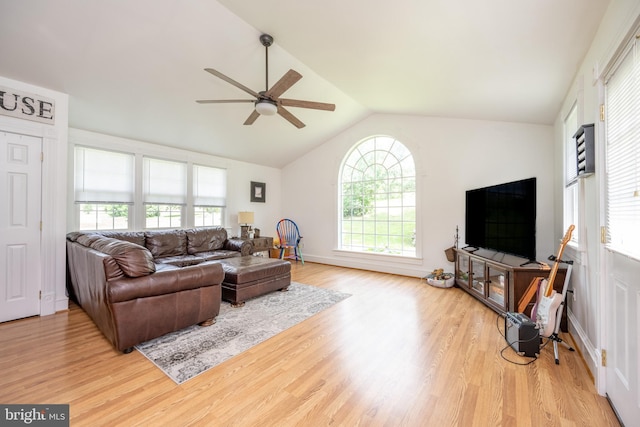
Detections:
0,263,618,427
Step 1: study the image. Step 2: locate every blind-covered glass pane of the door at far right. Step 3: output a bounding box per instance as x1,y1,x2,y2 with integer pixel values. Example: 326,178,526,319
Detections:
605,35,640,258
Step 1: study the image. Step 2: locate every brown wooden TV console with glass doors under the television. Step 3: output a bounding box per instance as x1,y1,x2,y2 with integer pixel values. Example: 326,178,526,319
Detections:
455,249,568,332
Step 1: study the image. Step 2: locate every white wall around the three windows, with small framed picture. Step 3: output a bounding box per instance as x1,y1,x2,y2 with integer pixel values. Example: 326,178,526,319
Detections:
67,129,281,241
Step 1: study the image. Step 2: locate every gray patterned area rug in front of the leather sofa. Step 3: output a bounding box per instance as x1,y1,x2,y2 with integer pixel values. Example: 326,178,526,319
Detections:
136,282,350,384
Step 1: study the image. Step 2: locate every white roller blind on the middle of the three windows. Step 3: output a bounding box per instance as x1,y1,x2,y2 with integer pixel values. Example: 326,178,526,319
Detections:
142,157,187,205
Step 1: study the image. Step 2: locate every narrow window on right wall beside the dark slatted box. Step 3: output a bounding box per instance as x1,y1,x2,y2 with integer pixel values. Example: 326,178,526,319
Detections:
563,103,580,242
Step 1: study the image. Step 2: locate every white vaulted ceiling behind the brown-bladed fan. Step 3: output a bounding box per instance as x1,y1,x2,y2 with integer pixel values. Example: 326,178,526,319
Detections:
0,0,610,168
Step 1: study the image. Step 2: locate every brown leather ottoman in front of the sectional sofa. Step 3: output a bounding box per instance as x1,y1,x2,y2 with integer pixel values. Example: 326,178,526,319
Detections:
219,256,291,307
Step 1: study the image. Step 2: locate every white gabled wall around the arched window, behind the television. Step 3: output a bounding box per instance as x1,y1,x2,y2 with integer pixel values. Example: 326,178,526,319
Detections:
282,114,555,277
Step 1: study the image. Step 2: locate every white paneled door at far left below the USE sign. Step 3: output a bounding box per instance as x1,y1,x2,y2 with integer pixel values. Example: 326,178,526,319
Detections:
0,131,42,322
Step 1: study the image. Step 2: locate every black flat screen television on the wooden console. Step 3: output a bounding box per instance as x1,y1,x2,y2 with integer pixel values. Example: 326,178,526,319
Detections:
465,178,536,261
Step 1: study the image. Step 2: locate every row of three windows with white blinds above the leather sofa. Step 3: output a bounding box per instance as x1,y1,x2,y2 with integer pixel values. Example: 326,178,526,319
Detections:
73,145,227,230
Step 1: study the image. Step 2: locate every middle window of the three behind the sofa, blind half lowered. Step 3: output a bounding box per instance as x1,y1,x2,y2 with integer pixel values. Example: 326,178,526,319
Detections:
142,157,187,228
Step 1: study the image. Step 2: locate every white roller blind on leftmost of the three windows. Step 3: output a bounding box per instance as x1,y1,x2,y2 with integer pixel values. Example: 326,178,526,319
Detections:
74,147,135,203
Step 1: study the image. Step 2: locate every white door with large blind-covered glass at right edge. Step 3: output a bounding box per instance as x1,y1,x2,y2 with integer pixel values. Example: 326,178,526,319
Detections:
600,27,640,425
